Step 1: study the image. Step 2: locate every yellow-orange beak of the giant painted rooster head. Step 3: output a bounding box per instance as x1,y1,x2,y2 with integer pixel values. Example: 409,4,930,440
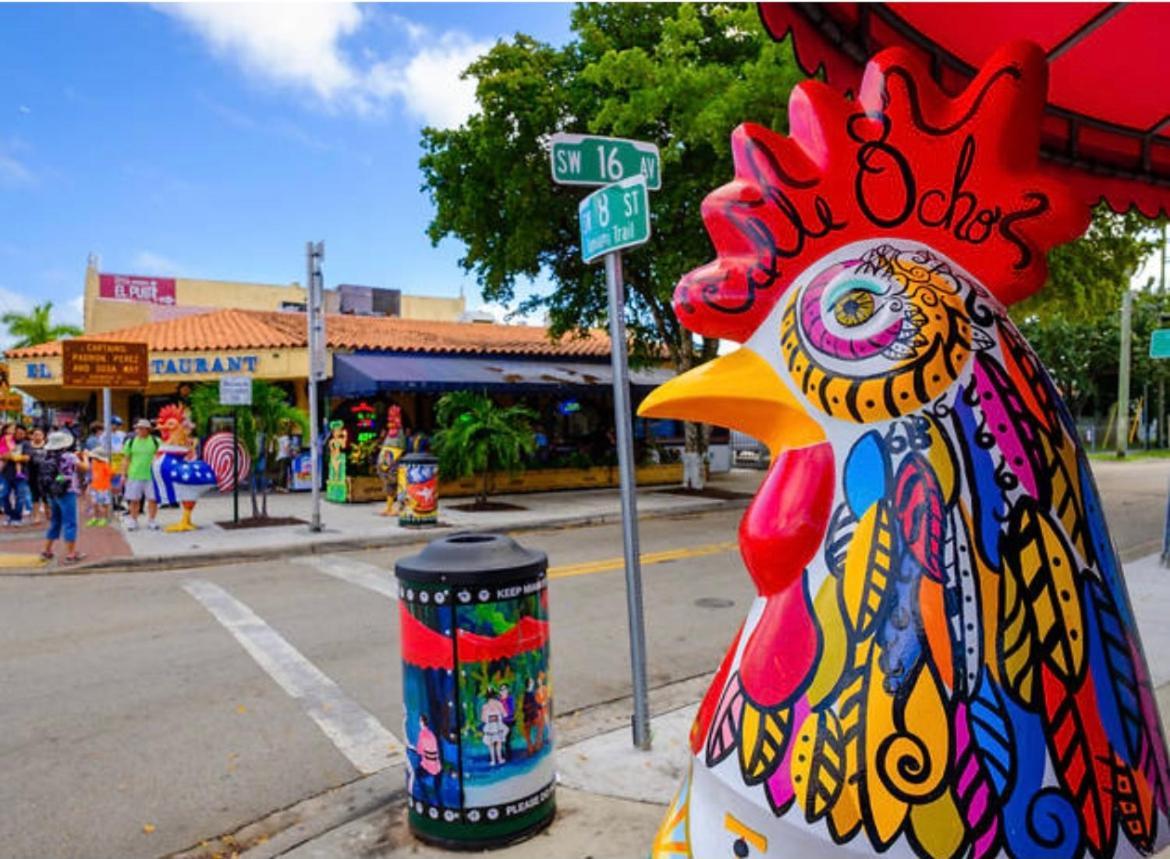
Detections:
638,346,825,459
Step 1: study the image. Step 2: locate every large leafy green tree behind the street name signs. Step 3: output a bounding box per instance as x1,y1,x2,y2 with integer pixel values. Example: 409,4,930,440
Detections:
421,4,803,379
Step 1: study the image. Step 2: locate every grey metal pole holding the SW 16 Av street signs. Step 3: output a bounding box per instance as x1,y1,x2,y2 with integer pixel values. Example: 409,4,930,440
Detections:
605,250,651,750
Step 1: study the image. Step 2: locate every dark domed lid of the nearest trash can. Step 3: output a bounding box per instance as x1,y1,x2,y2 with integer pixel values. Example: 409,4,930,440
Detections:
394,531,549,585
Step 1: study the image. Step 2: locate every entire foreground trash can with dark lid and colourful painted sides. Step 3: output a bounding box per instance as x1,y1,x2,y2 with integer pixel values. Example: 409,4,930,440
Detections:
394,534,556,848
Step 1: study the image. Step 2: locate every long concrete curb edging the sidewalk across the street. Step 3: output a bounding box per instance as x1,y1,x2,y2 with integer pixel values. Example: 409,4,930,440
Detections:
0,497,751,577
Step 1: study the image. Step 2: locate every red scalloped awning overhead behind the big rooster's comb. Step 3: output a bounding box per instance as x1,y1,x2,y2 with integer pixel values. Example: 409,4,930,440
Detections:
759,2,1170,217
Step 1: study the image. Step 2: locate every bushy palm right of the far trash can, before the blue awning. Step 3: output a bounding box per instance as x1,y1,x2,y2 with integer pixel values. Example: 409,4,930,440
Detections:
434,391,537,507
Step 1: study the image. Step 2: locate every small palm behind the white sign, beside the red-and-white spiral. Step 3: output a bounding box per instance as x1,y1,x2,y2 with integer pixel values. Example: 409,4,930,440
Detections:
190,379,309,518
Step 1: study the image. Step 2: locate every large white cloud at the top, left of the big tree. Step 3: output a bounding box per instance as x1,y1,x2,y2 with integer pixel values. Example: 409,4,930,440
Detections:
156,4,490,128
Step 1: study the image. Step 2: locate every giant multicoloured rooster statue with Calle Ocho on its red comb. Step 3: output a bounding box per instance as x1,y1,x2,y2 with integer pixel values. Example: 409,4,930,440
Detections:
641,43,1170,859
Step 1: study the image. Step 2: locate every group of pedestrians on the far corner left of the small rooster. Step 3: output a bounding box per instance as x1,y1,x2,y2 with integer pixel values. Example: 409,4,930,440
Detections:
0,417,170,563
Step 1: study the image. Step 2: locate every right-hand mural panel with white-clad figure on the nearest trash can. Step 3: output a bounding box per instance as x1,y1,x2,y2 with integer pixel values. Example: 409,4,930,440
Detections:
457,579,553,806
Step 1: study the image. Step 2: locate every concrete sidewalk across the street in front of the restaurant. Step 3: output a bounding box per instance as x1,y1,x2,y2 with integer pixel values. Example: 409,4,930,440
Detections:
0,469,764,575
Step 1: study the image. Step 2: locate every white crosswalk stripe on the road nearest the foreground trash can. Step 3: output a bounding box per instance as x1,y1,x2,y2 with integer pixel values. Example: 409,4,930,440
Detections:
183,578,402,775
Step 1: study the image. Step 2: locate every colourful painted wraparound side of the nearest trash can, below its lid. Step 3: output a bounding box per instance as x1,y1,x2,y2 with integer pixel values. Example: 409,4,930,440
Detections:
399,577,556,824
